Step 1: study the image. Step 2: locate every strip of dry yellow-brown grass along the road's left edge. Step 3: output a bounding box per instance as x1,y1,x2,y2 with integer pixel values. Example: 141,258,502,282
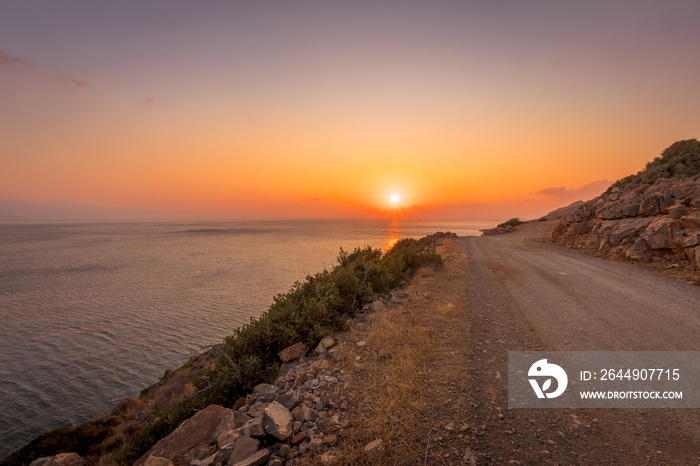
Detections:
312,241,476,465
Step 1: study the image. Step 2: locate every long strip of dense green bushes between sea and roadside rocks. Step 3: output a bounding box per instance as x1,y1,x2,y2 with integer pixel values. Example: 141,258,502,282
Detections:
117,238,442,465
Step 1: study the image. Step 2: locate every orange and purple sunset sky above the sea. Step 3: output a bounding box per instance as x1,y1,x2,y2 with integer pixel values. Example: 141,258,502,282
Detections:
0,0,700,220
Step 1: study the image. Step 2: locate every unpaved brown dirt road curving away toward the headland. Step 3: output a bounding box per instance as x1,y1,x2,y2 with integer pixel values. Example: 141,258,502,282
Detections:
456,222,700,465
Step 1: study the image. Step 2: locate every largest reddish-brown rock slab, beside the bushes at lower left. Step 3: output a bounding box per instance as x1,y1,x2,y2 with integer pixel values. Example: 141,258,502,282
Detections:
134,405,235,466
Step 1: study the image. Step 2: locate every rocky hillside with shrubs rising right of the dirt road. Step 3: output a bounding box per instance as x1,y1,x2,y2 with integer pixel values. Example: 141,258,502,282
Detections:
552,139,700,271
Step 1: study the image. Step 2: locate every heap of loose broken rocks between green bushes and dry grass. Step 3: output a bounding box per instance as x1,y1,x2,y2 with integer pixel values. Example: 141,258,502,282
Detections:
129,290,411,466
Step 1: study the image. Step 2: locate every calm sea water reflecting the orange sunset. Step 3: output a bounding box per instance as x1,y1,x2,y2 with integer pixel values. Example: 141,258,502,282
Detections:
0,221,489,457
